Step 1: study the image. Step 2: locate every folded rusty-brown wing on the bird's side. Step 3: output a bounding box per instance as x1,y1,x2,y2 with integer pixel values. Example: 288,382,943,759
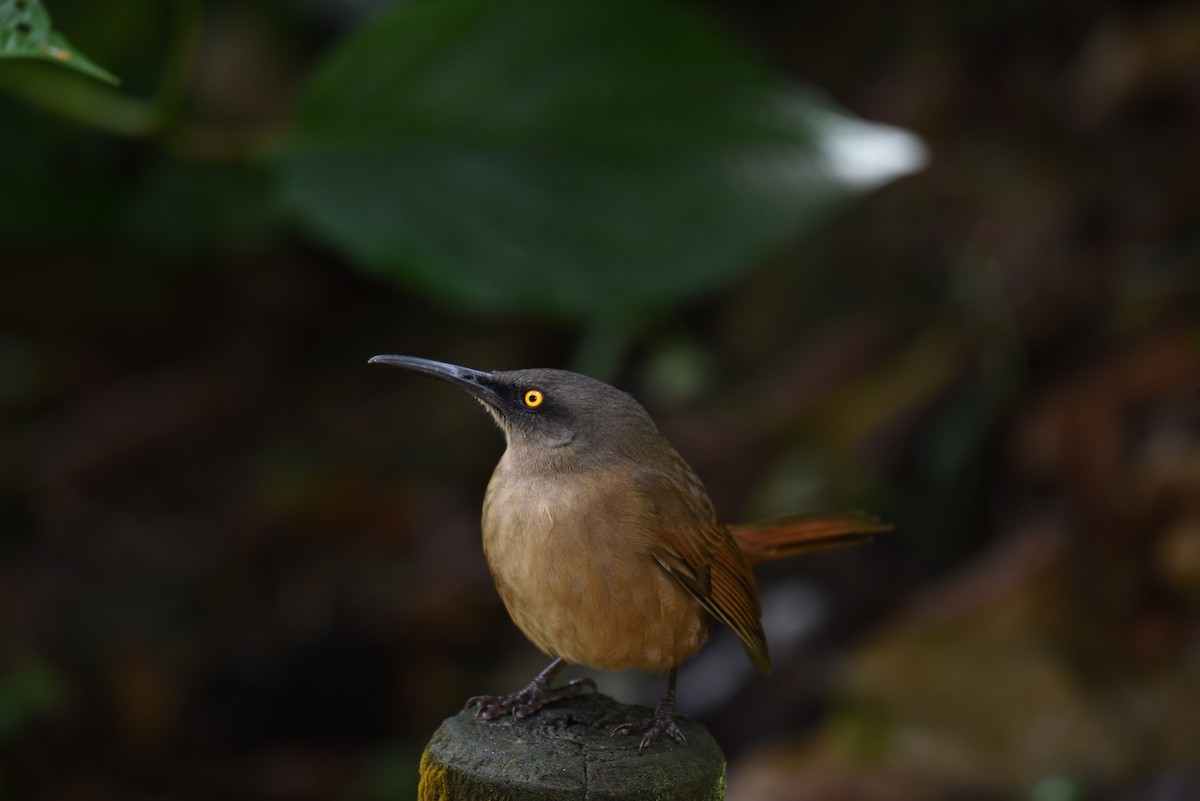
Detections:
638,469,770,674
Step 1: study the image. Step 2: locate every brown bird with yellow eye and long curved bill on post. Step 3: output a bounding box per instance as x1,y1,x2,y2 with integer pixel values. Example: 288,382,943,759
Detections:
368,355,890,753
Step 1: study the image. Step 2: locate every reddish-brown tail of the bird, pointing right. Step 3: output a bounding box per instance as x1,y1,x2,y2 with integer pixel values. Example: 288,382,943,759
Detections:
728,511,892,565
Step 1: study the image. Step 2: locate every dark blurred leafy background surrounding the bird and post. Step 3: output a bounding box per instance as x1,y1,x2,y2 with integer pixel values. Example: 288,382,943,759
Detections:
0,0,1200,801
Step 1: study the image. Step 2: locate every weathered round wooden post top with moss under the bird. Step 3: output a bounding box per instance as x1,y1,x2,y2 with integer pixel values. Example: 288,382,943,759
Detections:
418,693,725,801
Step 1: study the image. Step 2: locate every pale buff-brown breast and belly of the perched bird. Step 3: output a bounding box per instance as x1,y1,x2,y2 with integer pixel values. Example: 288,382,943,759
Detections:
484,472,709,673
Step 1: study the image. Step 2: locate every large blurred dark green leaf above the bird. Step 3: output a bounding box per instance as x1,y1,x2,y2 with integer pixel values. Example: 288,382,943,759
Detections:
275,0,916,318
